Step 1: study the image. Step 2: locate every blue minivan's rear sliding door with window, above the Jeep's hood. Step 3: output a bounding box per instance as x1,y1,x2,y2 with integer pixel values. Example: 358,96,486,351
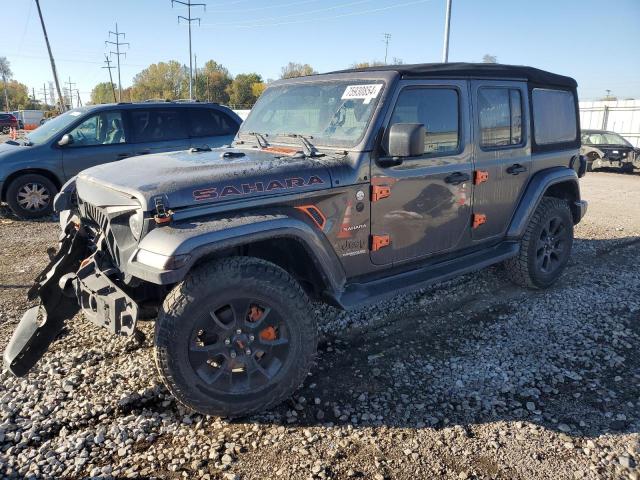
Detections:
129,106,190,155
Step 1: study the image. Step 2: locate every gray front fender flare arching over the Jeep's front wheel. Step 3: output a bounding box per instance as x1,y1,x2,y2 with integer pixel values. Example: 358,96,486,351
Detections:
127,214,345,292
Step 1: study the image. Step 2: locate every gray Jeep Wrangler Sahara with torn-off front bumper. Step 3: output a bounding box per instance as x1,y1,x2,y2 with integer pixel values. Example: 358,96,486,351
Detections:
4,63,587,416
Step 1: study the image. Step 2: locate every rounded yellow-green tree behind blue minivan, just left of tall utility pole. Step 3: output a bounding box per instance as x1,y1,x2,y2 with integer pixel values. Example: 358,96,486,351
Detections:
131,60,189,101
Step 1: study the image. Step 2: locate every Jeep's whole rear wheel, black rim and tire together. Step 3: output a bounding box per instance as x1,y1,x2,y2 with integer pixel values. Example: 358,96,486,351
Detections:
505,197,573,288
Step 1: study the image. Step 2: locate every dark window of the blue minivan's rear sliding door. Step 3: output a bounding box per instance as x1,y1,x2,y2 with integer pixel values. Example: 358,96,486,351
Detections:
130,108,188,143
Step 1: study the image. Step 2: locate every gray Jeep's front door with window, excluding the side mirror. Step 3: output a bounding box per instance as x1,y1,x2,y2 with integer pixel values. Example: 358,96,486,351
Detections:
371,80,473,265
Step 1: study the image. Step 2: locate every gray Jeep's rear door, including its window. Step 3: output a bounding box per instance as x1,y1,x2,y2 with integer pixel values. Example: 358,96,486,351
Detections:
471,80,531,244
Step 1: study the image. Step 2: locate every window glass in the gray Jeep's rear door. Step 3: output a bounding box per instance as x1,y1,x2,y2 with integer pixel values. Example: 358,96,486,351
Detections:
478,88,522,147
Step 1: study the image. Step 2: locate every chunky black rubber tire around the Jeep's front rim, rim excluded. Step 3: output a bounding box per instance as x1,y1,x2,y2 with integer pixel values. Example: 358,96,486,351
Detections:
155,257,318,418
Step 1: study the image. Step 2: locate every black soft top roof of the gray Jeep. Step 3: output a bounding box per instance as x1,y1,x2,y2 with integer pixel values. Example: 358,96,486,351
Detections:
331,62,578,88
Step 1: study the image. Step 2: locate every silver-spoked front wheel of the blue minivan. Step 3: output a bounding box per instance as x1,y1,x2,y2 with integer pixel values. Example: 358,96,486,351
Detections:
7,174,58,218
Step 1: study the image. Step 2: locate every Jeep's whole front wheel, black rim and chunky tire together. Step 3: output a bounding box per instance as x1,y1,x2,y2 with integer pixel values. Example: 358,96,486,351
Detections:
155,257,317,417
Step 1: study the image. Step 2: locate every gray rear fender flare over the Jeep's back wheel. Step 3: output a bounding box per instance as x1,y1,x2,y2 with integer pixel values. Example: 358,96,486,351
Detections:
507,167,581,240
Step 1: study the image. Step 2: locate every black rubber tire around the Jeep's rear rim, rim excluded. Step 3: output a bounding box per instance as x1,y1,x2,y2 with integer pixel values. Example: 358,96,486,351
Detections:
504,197,573,289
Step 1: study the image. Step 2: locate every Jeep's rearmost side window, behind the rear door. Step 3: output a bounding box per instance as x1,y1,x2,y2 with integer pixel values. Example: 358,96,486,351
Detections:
531,88,578,145
